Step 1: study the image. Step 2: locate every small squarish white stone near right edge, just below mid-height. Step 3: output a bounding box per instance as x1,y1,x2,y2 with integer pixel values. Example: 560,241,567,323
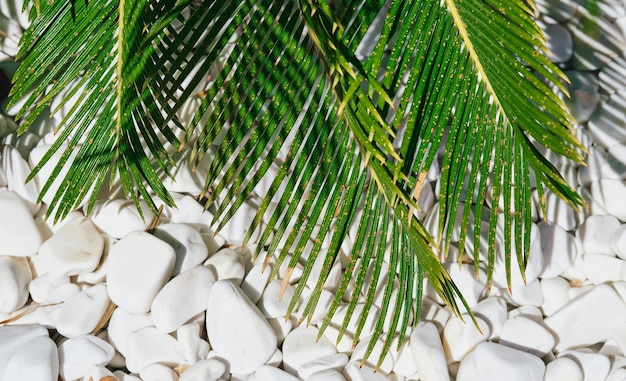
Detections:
577,216,620,255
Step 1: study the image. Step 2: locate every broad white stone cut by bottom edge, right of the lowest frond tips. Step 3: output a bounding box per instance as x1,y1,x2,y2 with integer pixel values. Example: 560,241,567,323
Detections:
456,342,545,381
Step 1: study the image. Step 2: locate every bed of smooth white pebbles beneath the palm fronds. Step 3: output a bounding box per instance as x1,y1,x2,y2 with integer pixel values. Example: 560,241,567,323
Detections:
0,0,626,381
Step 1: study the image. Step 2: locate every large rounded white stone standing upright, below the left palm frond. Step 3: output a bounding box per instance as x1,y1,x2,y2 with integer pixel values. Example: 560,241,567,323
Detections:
107,232,176,313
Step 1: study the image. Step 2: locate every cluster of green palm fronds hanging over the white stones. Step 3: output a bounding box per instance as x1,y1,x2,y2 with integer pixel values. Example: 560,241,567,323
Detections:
12,0,584,361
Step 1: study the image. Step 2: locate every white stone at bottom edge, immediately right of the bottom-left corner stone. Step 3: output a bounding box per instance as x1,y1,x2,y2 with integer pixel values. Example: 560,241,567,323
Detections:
59,335,115,380
